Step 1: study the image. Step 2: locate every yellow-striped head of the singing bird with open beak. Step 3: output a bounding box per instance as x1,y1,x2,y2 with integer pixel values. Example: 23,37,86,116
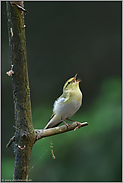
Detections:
63,74,81,91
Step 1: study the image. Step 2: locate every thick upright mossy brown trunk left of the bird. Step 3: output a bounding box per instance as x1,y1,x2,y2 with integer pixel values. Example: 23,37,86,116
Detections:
6,1,35,181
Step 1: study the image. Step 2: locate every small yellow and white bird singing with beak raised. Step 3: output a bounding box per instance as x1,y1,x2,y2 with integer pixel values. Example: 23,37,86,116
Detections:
44,74,82,129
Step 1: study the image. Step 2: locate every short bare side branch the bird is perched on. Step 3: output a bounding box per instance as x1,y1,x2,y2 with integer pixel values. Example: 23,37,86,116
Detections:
35,122,88,142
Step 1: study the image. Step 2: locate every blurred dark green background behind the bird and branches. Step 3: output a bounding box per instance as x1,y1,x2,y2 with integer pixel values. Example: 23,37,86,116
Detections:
1,1,122,182
